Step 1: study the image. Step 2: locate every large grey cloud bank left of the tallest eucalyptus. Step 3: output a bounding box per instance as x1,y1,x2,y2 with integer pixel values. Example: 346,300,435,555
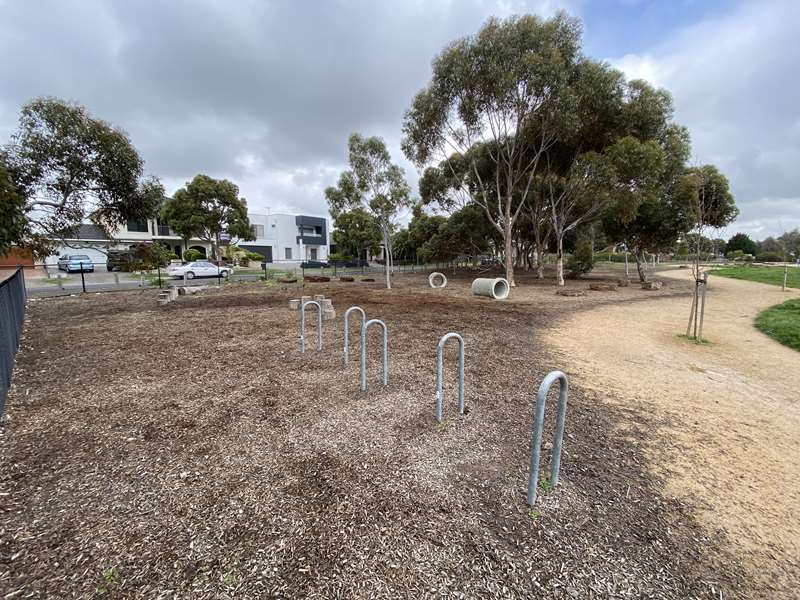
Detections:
0,0,566,218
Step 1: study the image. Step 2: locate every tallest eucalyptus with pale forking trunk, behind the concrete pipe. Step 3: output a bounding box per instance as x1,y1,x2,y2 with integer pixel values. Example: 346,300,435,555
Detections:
403,13,581,285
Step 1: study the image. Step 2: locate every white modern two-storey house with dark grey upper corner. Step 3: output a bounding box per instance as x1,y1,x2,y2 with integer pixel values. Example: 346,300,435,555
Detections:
244,214,329,263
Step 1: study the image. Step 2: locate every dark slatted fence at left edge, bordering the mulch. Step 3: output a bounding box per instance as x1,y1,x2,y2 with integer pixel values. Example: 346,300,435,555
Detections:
0,269,26,414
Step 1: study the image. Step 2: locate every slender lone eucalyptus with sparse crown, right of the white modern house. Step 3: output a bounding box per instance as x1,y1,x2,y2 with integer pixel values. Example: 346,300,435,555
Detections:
325,133,411,289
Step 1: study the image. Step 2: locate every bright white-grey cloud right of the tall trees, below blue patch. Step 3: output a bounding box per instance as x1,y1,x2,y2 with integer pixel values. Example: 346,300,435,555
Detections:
612,0,800,238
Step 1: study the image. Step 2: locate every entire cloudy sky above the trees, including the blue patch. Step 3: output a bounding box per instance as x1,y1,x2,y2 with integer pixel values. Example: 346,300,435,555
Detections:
0,0,800,238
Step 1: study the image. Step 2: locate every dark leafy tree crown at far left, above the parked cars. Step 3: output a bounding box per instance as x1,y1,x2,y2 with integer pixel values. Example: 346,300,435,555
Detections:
0,97,164,256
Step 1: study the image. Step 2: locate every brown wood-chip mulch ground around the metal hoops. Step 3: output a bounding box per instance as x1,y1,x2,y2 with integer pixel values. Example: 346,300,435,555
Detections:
0,273,746,599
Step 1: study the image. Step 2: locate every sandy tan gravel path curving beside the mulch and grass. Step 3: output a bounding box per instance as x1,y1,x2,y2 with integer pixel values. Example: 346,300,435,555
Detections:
548,271,800,598
